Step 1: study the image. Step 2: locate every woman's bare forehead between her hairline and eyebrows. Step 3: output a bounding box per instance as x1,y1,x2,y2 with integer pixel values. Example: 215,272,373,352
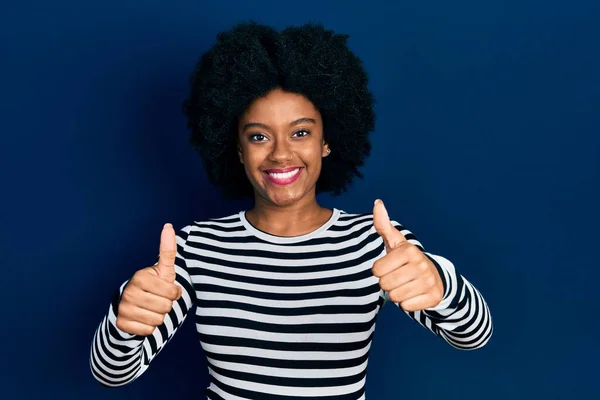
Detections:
241,89,320,123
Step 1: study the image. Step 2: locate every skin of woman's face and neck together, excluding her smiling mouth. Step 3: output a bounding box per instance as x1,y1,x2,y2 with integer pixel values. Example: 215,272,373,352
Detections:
238,89,332,236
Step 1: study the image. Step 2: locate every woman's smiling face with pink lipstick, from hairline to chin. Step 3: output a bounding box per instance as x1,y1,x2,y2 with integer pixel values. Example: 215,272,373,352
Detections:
238,89,328,206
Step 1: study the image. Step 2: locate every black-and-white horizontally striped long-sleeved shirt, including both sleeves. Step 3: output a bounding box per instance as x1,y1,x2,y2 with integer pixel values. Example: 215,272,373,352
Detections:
90,209,492,400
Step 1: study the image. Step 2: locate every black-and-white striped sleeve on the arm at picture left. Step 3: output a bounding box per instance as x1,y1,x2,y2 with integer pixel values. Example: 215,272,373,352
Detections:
90,226,195,387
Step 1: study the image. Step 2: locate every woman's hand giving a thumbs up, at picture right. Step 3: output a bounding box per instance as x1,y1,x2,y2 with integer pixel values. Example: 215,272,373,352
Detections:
372,200,444,311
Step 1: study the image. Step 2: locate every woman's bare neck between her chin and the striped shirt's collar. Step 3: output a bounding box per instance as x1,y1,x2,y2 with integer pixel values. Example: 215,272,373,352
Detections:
246,192,331,236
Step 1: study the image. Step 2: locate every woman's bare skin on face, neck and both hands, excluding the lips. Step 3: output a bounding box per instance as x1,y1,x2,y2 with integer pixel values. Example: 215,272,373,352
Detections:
116,89,444,336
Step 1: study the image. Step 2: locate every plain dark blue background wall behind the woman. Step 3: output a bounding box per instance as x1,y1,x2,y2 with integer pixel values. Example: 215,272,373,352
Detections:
0,0,600,400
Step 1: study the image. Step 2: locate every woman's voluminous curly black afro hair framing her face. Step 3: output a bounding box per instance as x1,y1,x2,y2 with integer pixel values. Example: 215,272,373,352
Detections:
183,21,375,199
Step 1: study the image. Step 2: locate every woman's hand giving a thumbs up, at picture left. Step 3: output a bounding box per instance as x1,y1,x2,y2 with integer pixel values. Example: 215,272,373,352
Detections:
116,224,182,336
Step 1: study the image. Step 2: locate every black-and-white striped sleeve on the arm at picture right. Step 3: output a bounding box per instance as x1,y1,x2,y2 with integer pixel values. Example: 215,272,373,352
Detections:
384,221,493,350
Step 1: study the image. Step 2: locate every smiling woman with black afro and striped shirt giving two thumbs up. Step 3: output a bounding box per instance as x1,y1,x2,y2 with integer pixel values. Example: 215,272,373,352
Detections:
90,23,492,399
